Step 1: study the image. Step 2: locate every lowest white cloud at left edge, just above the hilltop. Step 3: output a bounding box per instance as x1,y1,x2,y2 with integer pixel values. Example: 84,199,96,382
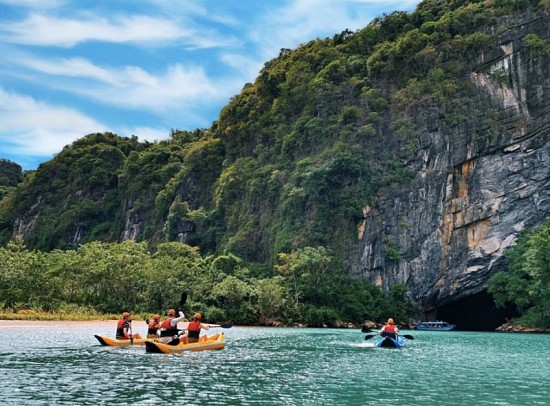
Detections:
0,88,106,156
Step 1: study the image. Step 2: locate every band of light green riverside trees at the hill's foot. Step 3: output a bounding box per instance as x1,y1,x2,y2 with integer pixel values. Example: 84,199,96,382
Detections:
0,241,408,326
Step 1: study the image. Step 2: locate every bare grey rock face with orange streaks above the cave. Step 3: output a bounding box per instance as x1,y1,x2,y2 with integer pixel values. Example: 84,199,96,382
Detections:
352,14,550,311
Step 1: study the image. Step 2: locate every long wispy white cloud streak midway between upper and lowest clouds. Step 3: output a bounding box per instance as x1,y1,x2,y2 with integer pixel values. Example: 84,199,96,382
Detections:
12,55,246,114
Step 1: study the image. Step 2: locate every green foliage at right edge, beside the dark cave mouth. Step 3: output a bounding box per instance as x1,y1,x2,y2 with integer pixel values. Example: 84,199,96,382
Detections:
488,221,550,328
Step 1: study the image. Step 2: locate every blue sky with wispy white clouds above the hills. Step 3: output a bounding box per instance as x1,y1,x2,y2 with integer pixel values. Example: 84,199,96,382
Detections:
0,0,420,170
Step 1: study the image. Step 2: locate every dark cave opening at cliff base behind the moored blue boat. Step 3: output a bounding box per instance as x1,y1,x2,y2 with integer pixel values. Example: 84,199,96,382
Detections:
437,290,518,331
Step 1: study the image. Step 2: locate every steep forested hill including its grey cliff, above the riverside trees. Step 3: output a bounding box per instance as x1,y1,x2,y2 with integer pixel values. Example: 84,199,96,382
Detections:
0,0,550,326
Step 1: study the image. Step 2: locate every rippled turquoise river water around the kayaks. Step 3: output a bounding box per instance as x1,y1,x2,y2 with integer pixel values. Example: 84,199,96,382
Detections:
0,322,550,406
